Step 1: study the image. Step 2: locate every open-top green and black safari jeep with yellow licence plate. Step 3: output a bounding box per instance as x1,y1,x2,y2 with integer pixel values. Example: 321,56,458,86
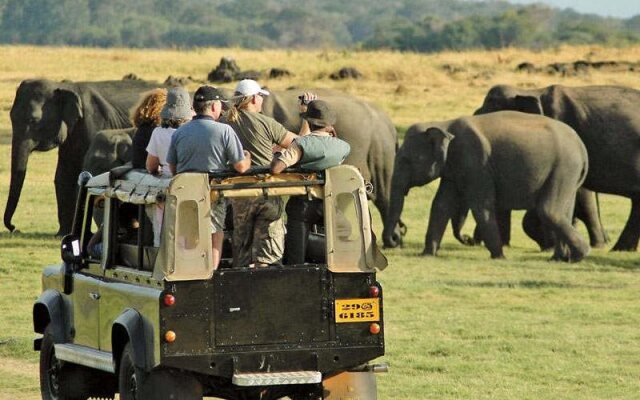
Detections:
33,166,386,400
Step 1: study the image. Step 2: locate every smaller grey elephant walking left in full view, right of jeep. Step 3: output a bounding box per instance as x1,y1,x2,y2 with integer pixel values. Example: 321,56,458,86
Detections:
383,111,589,262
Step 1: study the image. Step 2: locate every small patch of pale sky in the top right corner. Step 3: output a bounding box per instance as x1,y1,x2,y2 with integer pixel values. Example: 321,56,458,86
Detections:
508,0,640,19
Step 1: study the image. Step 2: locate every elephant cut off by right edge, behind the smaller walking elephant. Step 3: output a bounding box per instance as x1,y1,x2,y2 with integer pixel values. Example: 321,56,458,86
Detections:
475,85,640,251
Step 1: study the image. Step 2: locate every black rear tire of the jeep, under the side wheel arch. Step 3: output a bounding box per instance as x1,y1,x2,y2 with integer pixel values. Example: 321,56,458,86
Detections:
118,342,202,400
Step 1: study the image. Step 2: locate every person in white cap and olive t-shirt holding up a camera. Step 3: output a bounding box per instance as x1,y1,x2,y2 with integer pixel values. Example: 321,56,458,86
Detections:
224,79,316,267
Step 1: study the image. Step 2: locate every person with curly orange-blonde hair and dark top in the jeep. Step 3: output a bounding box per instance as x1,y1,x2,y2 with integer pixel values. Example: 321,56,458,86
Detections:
131,88,167,169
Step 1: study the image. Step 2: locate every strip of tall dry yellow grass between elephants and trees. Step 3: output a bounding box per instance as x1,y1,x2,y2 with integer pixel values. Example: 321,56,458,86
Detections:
0,46,640,134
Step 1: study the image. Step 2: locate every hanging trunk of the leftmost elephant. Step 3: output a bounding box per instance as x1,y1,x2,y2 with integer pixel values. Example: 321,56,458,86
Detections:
4,137,34,232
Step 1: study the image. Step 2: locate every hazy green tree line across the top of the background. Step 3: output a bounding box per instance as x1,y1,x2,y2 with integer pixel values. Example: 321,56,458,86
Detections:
0,0,640,52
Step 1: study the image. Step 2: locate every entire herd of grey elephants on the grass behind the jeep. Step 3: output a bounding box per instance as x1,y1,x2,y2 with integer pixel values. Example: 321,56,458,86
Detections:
4,80,640,262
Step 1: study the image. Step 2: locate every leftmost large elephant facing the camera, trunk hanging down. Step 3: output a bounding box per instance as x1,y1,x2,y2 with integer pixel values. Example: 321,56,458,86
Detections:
4,79,162,235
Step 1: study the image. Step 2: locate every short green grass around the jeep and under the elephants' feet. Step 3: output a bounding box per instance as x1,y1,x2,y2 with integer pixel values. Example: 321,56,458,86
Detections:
0,145,640,400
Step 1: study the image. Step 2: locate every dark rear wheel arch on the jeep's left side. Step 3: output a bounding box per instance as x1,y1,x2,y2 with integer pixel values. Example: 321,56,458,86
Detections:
111,308,155,374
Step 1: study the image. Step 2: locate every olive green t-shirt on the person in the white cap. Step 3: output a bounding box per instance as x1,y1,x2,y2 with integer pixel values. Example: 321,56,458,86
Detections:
224,110,288,166
